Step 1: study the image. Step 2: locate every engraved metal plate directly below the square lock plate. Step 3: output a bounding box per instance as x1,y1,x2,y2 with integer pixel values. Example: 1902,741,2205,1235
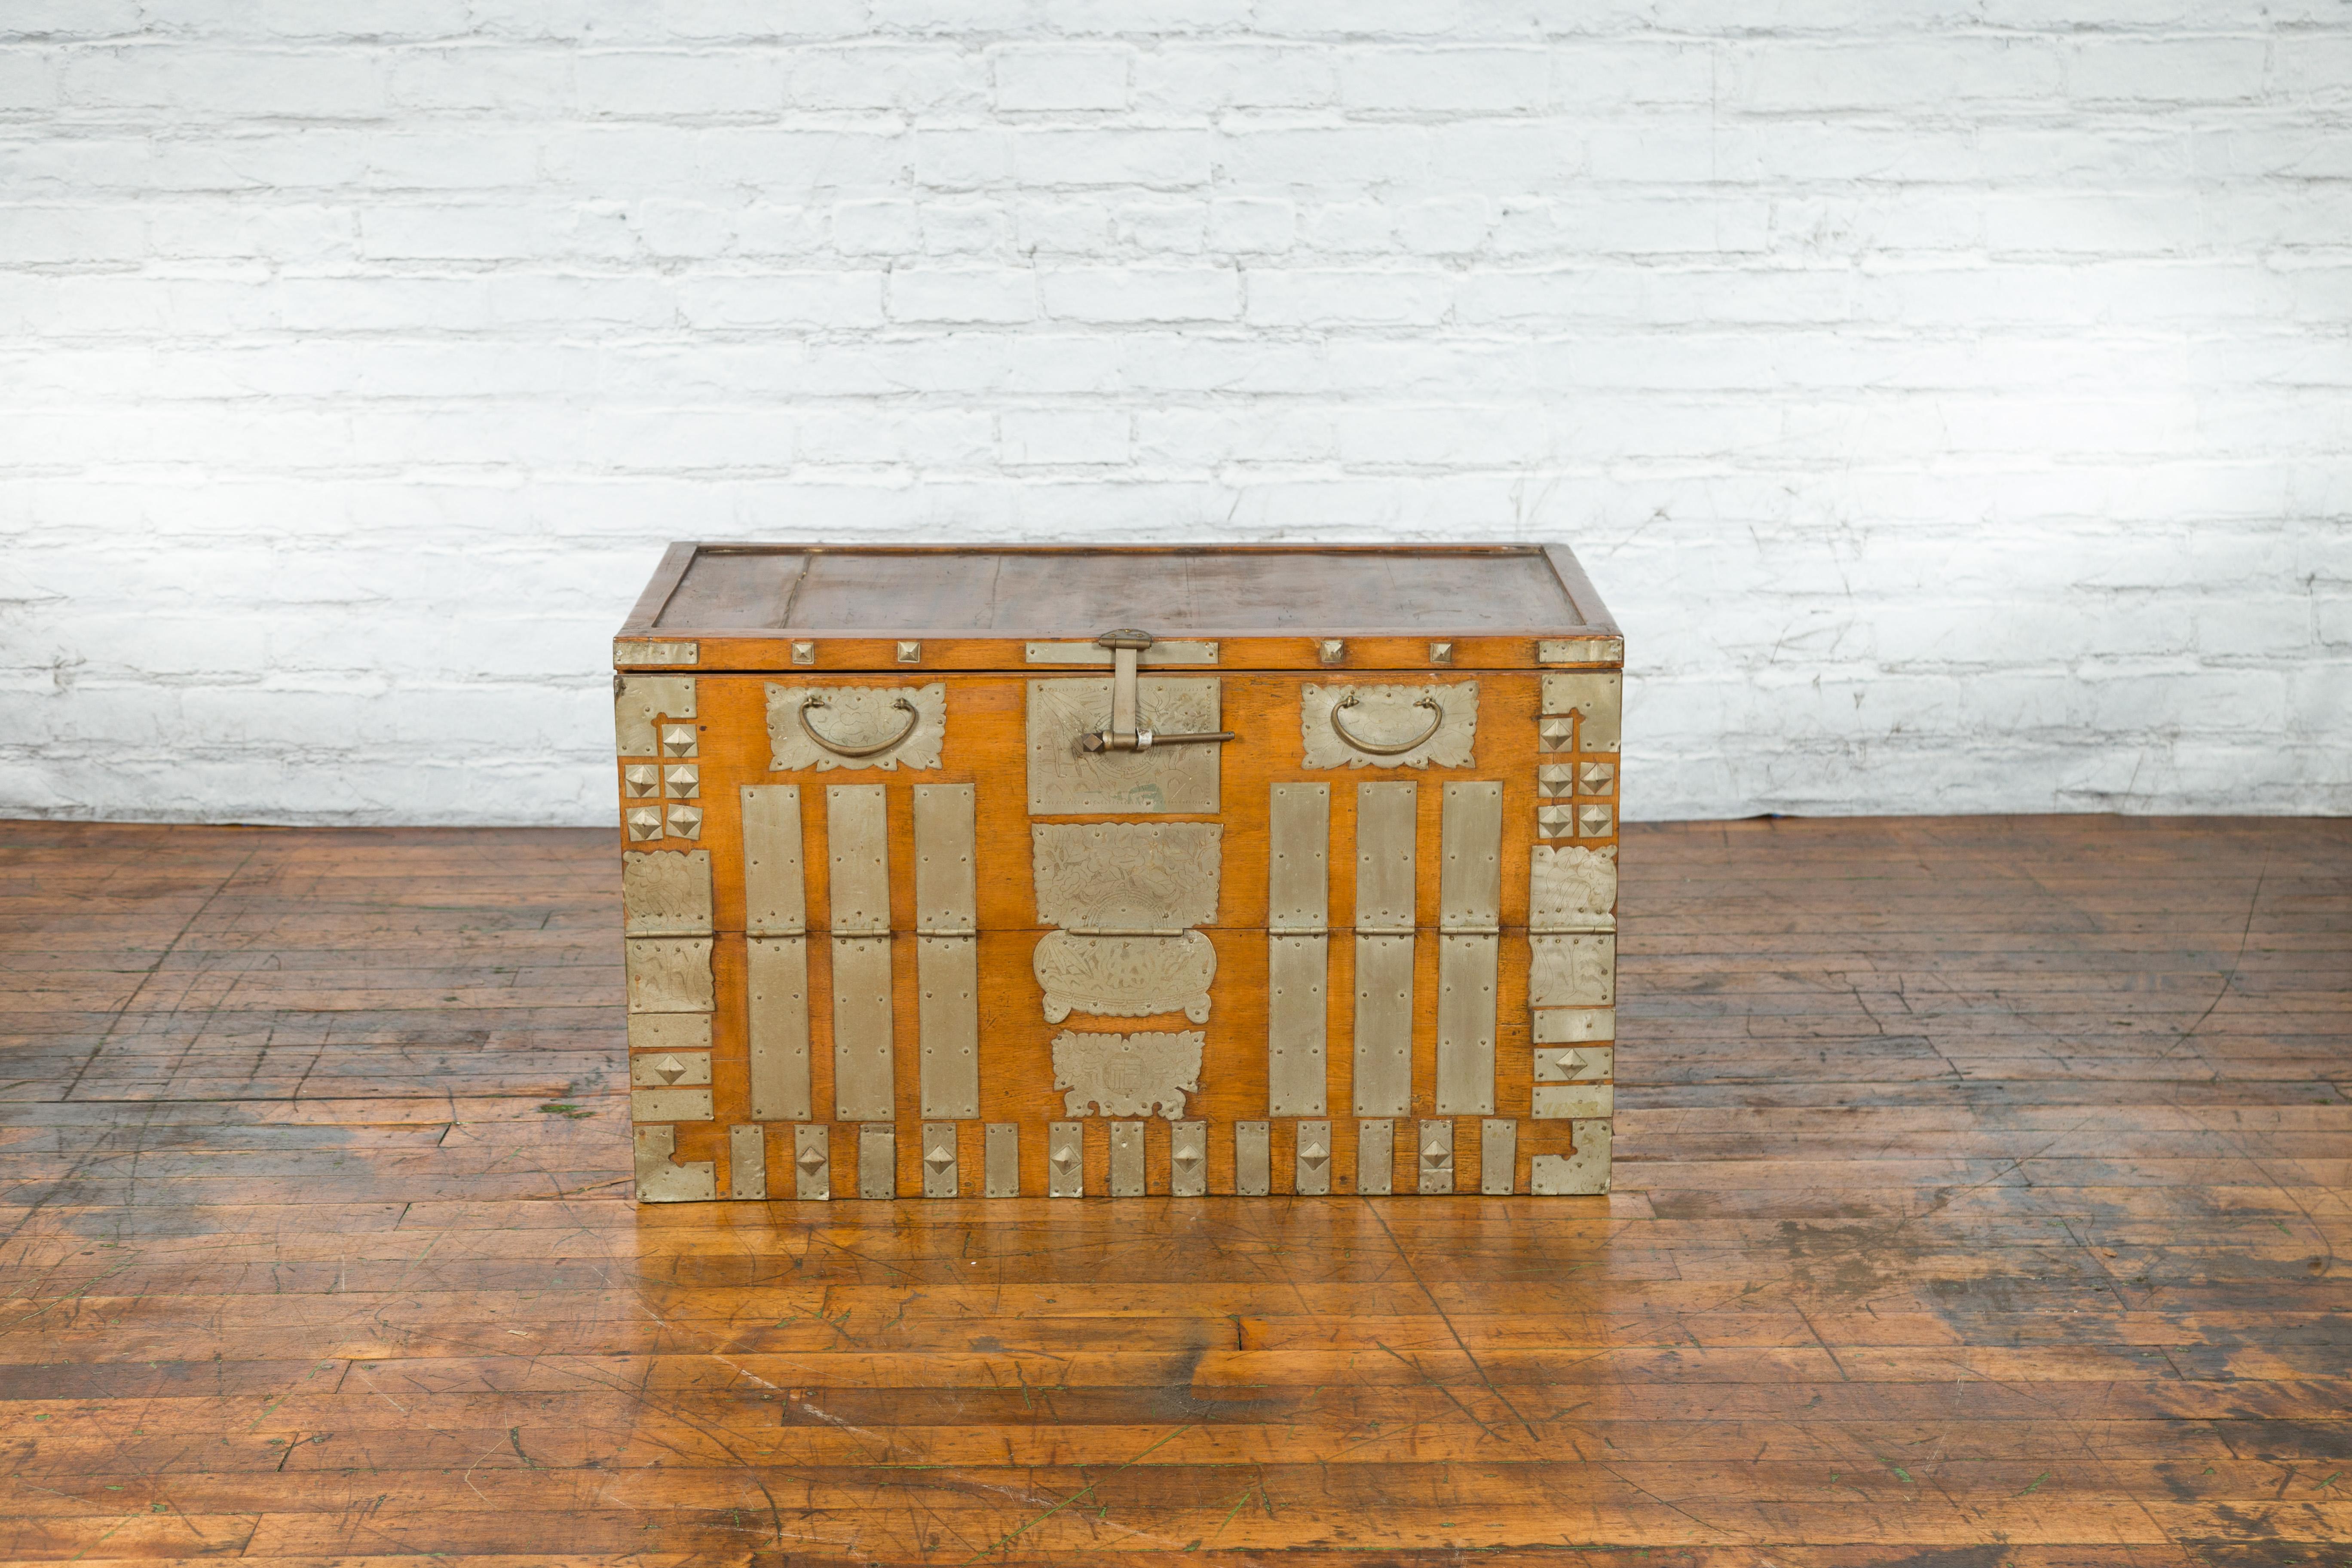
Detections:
1030,823,1223,936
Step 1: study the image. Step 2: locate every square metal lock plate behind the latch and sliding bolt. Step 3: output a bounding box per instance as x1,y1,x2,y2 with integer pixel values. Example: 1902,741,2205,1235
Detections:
1028,677,1225,818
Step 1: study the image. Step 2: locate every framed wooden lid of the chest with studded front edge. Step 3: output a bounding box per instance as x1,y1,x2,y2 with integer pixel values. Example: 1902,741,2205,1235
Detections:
614,543,1625,672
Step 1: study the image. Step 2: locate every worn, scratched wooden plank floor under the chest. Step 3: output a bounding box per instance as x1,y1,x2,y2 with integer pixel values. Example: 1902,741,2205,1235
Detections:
0,818,2352,1568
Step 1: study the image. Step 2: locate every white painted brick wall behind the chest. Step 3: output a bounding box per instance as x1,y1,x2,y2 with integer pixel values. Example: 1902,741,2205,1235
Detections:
0,0,2352,823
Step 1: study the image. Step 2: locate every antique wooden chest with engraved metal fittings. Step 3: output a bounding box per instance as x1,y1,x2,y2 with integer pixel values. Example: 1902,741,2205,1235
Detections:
614,545,1625,1204
